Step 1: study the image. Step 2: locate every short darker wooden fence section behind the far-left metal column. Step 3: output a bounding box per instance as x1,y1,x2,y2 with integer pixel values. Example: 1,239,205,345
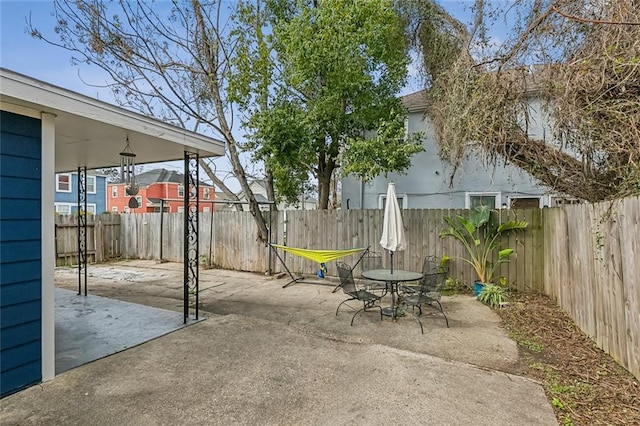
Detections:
55,214,120,266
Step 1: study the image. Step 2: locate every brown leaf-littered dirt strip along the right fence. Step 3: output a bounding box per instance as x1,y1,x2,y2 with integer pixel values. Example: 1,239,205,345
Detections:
498,293,640,425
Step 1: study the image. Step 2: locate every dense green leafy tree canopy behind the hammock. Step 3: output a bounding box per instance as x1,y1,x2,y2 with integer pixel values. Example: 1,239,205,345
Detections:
242,0,422,208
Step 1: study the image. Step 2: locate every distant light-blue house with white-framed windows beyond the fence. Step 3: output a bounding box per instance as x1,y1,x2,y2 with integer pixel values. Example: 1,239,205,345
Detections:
53,172,107,214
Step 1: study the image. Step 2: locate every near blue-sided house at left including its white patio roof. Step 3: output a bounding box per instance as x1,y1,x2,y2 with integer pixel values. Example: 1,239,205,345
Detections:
0,68,224,398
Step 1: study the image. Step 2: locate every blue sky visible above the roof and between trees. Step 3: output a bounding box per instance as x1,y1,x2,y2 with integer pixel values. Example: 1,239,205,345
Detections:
0,0,480,191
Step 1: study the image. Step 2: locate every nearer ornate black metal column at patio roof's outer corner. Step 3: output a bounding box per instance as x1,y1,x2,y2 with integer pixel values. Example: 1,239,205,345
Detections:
184,151,200,324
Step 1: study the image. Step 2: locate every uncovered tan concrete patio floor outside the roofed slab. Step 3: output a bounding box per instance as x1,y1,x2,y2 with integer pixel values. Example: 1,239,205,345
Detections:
0,261,557,425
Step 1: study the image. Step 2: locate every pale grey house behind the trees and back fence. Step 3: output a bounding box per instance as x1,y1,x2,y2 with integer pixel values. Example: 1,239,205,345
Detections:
341,80,577,209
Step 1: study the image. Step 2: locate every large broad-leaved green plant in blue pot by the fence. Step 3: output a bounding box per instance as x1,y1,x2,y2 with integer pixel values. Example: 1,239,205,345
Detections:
439,205,529,296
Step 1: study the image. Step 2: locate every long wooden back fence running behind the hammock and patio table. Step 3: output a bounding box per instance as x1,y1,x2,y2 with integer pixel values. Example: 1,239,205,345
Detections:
115,209,544,290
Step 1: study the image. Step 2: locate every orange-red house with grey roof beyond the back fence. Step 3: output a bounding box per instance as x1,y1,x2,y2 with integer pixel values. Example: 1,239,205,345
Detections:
107,169,215,213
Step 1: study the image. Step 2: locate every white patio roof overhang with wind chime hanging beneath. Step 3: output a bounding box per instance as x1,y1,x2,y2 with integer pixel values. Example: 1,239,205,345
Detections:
0,68,225,173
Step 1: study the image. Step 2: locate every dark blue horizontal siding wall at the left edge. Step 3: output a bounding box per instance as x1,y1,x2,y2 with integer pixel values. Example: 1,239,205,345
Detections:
0,111,42,396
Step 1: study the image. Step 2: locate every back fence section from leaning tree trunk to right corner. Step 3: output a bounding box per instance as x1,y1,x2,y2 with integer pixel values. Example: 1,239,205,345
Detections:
274,209,544,290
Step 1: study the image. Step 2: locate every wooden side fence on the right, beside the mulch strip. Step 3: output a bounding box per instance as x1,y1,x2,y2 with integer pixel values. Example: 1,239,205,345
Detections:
540,197,640,378
